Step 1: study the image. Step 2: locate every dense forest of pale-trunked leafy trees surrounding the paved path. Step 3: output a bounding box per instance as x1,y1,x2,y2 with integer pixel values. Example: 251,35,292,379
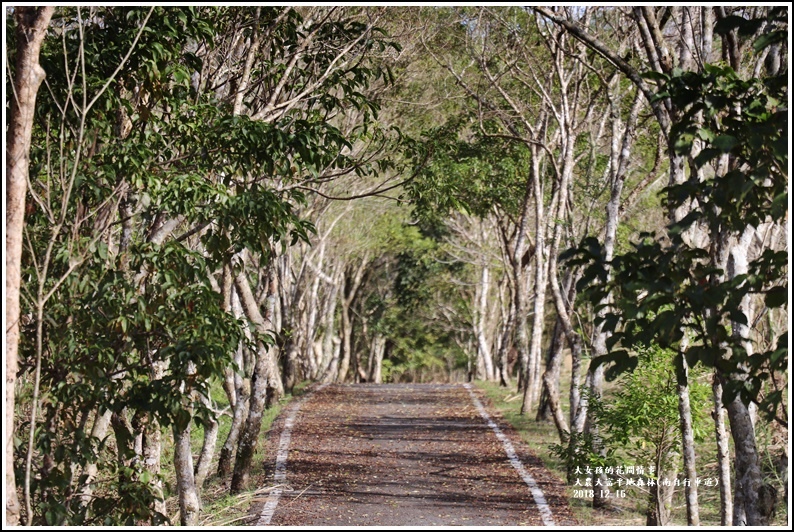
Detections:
4,6,790,525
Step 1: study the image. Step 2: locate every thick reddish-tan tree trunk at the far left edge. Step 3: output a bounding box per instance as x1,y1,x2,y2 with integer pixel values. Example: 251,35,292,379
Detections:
4,6,55,526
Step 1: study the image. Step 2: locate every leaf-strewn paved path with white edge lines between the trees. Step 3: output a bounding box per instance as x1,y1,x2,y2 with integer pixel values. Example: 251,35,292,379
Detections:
254,384,575,526
